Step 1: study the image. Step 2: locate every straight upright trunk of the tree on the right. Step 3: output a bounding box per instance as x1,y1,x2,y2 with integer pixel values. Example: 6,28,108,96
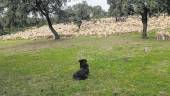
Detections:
141,7,148,39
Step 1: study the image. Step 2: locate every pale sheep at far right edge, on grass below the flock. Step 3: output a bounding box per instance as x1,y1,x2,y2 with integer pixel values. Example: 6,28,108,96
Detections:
156,31,170,40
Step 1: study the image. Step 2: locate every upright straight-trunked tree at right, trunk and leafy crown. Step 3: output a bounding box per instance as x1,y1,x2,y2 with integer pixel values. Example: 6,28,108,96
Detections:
130,0,165,39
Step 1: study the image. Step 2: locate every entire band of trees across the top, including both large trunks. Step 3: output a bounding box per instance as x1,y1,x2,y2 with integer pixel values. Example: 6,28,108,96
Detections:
0,0,170,39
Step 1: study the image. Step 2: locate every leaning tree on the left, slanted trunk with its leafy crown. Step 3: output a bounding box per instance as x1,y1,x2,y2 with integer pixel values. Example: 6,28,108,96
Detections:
23,0,67,39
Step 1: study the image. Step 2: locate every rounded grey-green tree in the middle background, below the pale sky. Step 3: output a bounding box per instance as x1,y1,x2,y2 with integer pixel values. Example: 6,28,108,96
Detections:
62,1,107,28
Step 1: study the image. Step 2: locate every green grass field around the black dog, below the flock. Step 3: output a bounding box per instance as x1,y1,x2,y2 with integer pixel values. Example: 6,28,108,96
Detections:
0,33,170,96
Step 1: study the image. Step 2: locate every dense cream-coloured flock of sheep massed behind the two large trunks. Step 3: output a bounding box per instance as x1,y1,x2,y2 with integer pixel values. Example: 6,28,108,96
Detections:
0,16,170,40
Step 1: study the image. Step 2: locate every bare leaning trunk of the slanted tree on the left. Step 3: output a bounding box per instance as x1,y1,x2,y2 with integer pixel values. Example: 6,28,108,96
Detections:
45,14,60,40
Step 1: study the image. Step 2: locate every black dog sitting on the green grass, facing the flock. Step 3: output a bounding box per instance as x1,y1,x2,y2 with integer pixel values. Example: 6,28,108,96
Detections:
73,59,89,80
